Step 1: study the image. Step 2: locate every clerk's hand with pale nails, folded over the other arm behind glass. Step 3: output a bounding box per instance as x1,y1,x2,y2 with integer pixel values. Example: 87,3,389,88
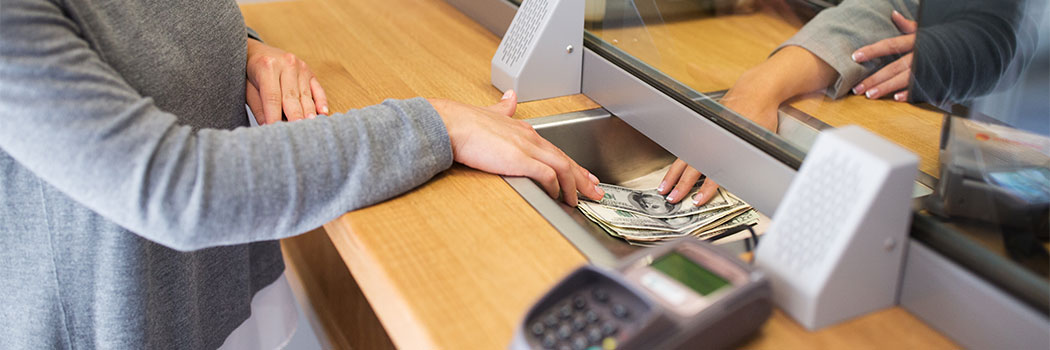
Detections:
851,11,919,101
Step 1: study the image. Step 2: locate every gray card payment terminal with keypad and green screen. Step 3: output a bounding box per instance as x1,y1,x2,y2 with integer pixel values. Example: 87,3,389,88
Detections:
510,239,772,350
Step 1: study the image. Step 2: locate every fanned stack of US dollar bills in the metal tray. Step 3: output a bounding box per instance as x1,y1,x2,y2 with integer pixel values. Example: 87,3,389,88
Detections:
579,184,759,246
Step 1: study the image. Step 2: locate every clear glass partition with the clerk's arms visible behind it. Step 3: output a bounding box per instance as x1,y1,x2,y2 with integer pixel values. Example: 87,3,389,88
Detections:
585,0,1050,313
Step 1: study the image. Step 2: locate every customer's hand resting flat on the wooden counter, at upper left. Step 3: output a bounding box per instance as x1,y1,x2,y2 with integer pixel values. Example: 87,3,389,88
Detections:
245,39,329,125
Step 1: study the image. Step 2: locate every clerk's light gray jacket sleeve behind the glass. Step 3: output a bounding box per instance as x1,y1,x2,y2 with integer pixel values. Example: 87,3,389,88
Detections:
774,0,919,98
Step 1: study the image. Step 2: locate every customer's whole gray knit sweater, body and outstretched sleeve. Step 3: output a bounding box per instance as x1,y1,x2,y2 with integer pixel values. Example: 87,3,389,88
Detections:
0,0,452,349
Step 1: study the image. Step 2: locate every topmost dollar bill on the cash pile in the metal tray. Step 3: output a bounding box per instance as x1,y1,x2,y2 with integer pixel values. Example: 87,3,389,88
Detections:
581,184,739,219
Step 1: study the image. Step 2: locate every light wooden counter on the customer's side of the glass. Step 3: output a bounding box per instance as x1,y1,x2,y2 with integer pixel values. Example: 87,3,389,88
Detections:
243,0,953,349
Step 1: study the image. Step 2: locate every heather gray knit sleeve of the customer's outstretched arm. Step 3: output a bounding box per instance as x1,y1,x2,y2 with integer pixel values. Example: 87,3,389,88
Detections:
0,1,453,250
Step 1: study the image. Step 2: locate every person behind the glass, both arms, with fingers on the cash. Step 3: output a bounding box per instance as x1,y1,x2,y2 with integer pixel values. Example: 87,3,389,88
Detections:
657,0,1045,205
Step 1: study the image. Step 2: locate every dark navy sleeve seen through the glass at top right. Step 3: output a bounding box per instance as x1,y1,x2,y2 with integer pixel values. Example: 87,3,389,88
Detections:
905,0,1048,107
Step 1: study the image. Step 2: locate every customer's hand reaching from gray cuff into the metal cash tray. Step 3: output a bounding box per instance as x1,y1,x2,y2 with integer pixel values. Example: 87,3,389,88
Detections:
428,90,605,206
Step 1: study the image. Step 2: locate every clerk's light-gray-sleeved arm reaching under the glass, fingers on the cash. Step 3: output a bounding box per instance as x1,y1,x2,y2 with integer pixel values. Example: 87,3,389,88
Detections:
657,0,918,205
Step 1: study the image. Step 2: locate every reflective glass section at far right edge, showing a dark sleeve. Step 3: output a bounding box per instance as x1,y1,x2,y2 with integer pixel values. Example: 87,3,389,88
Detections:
907,0,1050,279
